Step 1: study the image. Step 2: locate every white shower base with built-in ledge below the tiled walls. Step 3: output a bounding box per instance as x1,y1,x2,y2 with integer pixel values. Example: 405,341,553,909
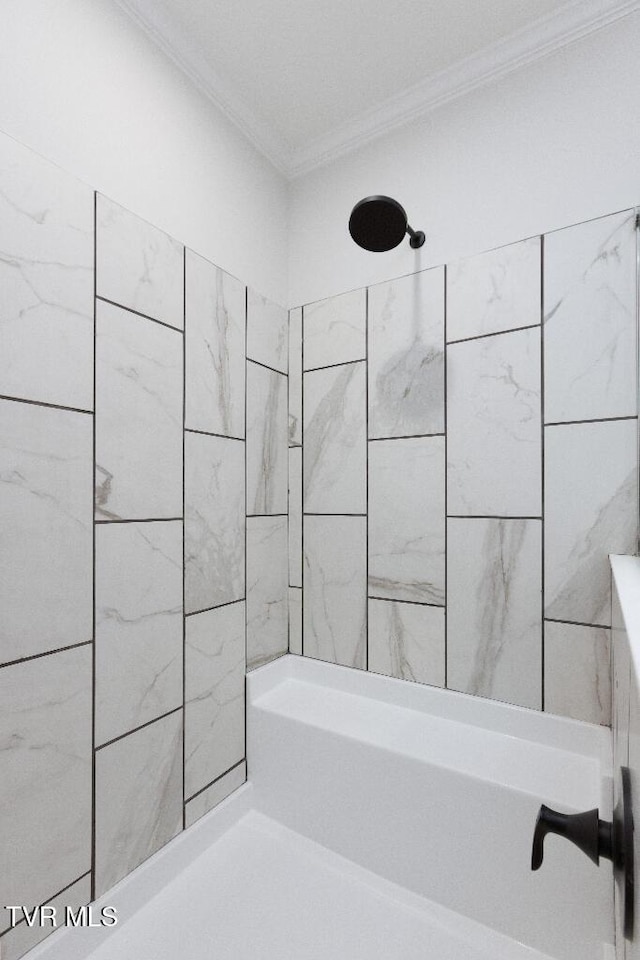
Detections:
22,656,614,960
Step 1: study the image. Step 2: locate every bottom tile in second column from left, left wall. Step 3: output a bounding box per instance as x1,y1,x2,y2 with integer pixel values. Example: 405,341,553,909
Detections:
95,710,182,897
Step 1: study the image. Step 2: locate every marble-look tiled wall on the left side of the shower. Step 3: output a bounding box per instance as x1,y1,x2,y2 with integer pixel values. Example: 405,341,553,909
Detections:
0,129,288,960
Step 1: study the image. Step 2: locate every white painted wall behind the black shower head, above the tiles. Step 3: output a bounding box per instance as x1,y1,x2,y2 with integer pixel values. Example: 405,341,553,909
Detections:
289,13,640,306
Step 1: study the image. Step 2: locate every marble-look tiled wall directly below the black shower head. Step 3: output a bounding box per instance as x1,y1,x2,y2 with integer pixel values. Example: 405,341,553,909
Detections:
289,210,638,724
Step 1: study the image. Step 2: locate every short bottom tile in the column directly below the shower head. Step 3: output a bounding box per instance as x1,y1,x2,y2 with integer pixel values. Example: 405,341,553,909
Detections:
369,600,445,687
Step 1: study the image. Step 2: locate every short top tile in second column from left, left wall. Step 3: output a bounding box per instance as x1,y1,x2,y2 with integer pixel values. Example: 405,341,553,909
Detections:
96,194,184,330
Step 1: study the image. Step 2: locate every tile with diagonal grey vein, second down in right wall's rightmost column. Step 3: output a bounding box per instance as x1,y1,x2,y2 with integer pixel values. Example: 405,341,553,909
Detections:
544,420,638,626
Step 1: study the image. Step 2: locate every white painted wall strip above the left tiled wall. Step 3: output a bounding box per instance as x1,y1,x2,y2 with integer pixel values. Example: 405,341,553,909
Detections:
0,0,287,303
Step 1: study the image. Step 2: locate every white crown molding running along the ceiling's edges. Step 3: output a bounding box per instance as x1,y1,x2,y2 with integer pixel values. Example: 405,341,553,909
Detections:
116,0,640,179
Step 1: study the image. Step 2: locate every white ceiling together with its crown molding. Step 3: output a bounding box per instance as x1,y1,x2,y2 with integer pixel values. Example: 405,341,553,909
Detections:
117,0,640,176
